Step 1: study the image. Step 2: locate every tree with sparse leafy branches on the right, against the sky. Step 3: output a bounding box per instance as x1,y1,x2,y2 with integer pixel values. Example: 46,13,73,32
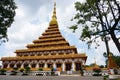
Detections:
70,0,120,52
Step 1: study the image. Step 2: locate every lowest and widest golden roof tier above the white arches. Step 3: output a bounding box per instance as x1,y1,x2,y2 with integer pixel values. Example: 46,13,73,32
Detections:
1,54,87,61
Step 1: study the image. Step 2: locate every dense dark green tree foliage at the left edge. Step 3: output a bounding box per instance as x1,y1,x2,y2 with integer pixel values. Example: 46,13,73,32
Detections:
0,0,17,44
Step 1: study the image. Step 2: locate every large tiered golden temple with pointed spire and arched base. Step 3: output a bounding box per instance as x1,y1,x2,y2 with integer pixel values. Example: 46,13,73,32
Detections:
1,2,87,72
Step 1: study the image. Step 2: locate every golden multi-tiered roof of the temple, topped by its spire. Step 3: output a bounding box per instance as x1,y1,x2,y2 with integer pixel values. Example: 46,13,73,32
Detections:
2,0,87,61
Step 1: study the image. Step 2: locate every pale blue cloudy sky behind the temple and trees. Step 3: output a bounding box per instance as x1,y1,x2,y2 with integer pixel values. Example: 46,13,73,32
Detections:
0,0,119,65
